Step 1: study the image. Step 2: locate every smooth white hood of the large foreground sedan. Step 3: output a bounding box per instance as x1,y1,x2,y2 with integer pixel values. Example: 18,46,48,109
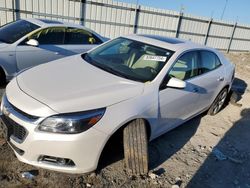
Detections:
16,55,144,113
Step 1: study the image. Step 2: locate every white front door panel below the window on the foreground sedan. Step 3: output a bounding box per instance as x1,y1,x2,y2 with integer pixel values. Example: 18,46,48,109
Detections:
158,81,202,133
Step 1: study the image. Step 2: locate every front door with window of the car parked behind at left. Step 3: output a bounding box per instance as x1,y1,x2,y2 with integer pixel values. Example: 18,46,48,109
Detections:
16,27,68,71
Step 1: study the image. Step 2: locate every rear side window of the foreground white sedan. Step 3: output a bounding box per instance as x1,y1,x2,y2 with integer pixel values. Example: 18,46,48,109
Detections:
200,51,221,73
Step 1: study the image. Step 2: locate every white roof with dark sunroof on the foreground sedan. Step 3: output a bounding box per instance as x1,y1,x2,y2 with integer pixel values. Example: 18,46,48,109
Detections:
123,34,214,51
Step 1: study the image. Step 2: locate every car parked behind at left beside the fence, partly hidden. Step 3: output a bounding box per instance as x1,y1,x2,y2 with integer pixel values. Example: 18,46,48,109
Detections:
0,19,107,84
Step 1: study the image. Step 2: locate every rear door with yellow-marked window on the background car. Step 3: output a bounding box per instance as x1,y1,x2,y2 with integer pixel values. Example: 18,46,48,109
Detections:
65,28,102,54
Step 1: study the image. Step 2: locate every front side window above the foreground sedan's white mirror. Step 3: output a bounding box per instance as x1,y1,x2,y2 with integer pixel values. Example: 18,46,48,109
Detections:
169,51,199,80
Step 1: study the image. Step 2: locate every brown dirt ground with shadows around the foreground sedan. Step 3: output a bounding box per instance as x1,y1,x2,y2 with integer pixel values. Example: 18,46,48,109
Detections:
0,53,250,188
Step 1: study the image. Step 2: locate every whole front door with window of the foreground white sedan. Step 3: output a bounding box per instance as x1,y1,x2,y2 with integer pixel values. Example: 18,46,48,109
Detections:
158,51,203,135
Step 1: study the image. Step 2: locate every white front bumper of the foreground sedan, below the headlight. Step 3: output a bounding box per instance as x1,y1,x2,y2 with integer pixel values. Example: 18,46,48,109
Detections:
1,108,108,173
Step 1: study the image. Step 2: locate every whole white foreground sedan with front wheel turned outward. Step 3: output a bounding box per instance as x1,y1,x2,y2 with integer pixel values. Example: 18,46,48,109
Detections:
1,35,234,174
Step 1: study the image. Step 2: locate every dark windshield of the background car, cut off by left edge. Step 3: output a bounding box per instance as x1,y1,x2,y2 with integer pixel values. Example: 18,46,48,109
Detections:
0,20,39,44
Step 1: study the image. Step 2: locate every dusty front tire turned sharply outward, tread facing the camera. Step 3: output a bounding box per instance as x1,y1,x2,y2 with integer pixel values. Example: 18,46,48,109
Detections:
123,119,148,175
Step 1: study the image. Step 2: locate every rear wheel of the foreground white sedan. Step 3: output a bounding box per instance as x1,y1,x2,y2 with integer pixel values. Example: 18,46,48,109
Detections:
208,88,228,116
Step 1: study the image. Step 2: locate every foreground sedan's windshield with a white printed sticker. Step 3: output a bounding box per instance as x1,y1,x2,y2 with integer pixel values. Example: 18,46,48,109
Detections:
82,38,173,82
